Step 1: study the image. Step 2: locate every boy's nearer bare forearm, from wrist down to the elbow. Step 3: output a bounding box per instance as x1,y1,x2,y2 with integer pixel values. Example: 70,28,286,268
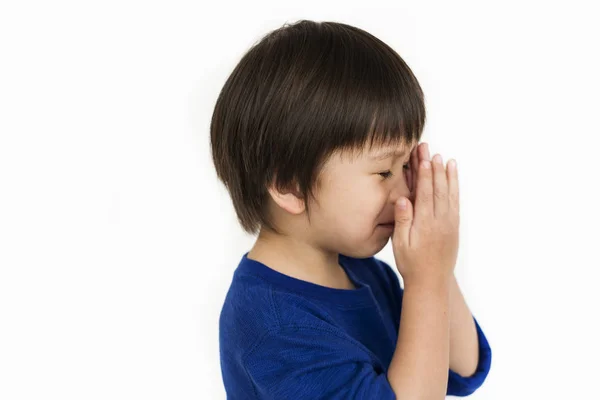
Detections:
387,281,450,400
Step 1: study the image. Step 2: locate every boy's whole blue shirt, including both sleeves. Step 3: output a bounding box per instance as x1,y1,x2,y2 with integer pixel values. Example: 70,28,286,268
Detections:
219,253,492,400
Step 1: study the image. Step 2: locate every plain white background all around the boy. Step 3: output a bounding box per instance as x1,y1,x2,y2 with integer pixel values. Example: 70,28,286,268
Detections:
0,0,600,400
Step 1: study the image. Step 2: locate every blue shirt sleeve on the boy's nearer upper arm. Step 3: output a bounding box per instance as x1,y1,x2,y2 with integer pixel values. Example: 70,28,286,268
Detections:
242,326,396,400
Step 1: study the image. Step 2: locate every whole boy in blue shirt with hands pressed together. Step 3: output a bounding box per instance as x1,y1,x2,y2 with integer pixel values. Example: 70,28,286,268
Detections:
211,20,491,400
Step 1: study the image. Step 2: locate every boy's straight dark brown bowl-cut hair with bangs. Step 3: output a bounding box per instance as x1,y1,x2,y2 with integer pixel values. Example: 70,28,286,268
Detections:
210,20,425,234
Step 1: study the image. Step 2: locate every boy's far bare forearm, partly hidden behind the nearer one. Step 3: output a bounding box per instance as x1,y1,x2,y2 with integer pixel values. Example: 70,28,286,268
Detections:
450,274,479,377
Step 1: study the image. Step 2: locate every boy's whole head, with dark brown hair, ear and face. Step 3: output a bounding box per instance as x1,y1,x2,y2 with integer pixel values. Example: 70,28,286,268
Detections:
210,20,425,257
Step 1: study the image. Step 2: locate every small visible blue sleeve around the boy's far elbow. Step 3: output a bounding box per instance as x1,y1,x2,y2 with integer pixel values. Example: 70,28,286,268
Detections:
447,317,492,397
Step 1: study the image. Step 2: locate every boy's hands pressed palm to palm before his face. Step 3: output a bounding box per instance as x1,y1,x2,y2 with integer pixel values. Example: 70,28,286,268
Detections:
392,143,459,283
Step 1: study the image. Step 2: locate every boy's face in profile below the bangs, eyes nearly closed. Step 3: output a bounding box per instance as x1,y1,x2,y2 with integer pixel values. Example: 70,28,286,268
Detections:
311,143,417,258
